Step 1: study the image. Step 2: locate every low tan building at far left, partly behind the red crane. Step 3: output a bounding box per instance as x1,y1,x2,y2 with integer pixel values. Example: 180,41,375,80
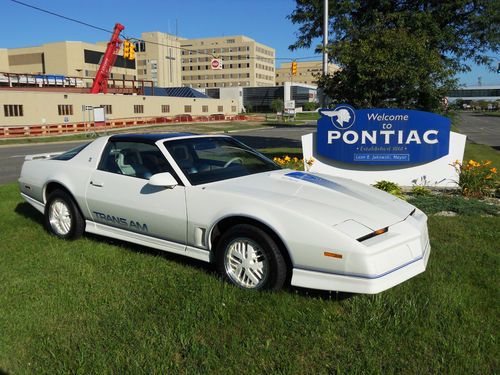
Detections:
7,41,137,86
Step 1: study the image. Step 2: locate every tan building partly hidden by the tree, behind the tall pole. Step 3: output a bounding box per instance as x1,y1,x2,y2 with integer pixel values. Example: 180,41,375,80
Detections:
276,61,339,86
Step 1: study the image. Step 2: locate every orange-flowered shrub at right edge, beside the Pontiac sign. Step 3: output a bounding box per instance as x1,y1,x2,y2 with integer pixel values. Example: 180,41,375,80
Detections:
452,160,497,198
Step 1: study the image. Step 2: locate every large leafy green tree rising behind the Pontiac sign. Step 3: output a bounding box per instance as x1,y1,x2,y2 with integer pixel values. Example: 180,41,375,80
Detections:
289,0,500,111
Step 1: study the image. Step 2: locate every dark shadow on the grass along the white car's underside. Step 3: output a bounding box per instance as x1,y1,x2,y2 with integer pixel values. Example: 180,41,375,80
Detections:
13,202,355,302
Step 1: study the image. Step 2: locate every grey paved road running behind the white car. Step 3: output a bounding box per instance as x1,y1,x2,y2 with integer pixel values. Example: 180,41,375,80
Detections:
0,126,315,184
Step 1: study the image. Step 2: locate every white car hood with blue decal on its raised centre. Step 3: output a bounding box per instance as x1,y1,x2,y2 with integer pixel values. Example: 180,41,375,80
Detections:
206,170,414,231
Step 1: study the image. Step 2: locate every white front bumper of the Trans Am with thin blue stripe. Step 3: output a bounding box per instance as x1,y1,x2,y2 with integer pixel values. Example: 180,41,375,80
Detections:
291,210,431,294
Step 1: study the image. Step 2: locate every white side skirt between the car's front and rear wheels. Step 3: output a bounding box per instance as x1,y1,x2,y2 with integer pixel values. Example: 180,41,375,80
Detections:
85,220,210,262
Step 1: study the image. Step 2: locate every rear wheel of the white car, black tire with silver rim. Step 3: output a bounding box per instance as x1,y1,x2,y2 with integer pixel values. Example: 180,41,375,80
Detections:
44,190,85,240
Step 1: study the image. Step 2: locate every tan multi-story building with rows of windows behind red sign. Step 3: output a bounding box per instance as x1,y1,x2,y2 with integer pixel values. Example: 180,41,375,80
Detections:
181,35,275,88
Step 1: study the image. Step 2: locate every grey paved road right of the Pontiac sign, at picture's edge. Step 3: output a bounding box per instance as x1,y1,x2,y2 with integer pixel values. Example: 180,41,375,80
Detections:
457,113,500,150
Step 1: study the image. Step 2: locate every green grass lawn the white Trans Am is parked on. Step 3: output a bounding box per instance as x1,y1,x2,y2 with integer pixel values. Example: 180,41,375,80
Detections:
0,180,500,374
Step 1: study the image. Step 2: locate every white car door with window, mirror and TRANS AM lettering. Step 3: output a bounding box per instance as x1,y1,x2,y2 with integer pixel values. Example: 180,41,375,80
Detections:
86,140,187,250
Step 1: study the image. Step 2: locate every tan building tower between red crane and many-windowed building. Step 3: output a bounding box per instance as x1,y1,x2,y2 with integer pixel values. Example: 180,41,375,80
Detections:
136,31,182,87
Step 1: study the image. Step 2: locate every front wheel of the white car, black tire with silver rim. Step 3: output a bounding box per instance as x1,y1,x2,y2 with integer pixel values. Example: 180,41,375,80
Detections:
216,224,287,291
